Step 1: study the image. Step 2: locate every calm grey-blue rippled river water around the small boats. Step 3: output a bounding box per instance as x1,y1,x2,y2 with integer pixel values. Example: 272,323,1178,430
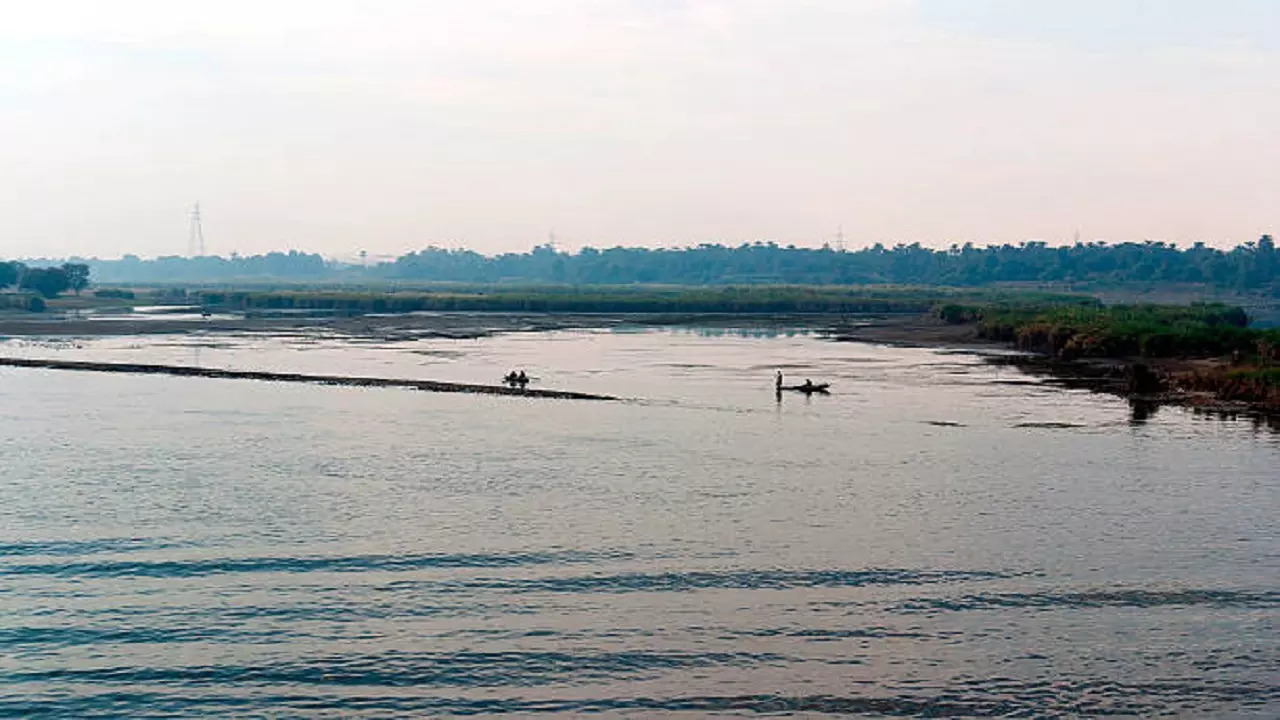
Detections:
0,329,1280,717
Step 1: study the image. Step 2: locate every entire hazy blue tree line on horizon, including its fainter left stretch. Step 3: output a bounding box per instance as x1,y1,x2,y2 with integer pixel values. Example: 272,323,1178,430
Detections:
40,236,1280,296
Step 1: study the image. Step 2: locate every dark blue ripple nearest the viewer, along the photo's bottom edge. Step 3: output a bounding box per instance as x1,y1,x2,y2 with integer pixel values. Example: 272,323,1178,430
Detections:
0,678,1280,717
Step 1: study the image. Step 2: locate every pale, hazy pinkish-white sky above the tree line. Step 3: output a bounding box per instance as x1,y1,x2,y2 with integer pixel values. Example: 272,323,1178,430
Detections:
0,0,1280,256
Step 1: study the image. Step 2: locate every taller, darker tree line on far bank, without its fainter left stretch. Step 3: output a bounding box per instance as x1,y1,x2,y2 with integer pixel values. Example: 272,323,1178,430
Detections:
374,236,1280,291
